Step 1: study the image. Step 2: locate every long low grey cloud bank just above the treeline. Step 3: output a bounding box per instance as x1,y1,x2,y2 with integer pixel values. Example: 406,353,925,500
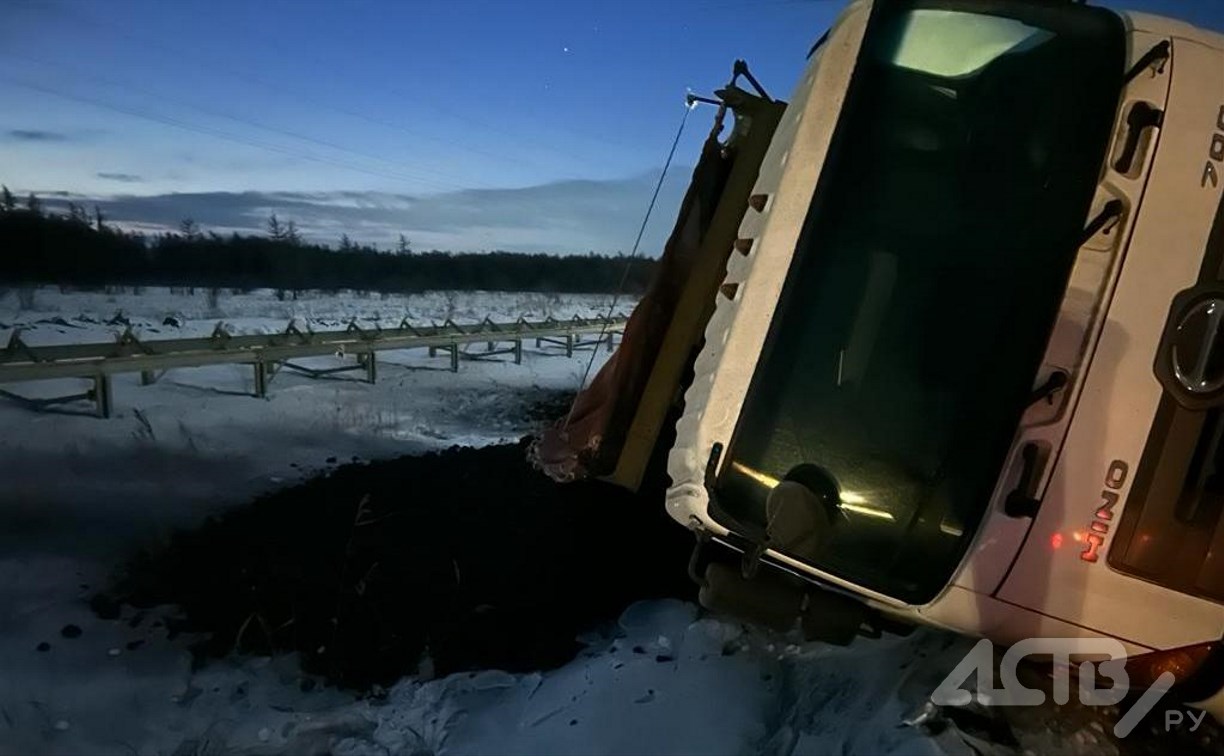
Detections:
35,168,689,256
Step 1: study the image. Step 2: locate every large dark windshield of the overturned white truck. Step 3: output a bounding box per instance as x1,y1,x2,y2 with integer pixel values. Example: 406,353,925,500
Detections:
712,1,1125,603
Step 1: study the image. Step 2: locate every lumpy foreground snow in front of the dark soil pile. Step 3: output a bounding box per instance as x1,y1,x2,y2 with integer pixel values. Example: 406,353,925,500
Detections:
0,560,968,755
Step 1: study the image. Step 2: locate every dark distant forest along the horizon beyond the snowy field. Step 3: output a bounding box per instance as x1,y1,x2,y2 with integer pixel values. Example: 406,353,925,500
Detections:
0,187,655,292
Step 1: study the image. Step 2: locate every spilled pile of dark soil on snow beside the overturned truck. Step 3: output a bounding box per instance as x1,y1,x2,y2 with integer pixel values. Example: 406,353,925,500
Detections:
115,442,694,687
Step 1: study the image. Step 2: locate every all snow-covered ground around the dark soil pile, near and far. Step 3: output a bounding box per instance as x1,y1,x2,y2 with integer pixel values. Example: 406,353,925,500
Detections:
0,289,1155,755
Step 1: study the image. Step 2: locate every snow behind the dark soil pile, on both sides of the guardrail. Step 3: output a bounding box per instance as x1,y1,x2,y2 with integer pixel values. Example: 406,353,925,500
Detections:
0,287,633,549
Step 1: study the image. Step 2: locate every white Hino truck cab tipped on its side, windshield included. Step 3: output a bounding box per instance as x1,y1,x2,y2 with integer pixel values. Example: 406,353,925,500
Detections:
667,0,1224,710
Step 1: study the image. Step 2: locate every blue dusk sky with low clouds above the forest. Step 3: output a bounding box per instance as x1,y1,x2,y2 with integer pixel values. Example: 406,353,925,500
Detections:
7,0,1224,253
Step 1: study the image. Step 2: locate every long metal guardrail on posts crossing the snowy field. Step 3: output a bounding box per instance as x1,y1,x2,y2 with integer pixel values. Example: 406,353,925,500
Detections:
0,317,625,417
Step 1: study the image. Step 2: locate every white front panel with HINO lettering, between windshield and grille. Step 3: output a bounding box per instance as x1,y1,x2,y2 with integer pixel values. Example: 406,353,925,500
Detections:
999,39,1224,648
